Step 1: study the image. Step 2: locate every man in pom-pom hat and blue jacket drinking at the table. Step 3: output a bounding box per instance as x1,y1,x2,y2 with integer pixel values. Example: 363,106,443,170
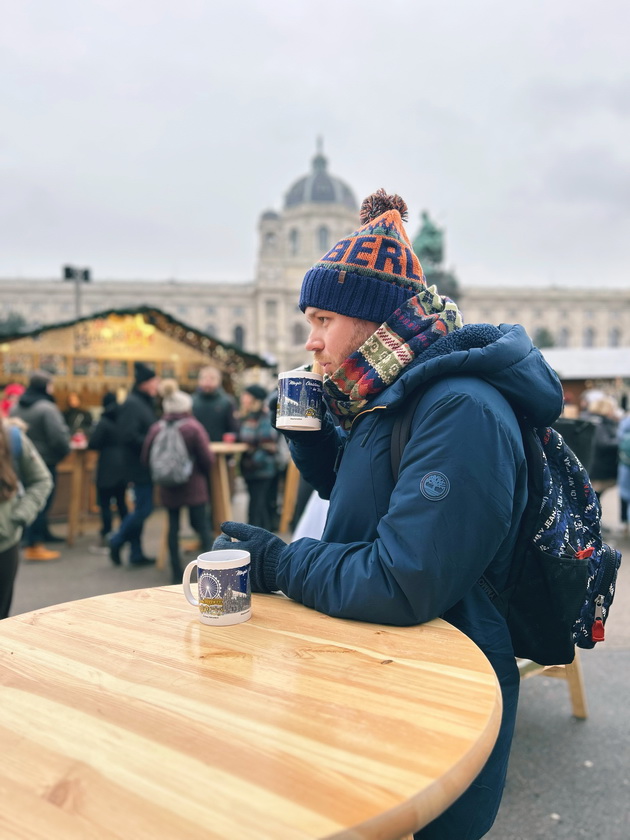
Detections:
216,190,562,840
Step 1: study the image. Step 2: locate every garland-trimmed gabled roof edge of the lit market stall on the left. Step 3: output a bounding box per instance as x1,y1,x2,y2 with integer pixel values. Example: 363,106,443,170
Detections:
0,306,273,368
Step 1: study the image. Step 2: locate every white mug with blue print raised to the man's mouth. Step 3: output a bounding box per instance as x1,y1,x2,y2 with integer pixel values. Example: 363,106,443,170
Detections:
276,369,323,432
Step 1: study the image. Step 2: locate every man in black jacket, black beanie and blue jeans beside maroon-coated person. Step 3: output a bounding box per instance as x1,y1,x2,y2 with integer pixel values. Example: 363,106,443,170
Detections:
109,362,160,566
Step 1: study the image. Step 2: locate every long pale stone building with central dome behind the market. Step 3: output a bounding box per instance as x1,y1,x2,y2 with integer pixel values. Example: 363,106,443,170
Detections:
0,151,630,378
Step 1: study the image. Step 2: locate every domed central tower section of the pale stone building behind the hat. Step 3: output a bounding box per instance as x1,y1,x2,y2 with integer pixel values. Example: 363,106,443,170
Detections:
255,143,359,370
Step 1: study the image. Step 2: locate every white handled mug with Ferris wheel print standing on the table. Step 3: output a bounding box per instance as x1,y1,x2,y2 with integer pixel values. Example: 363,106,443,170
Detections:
182,548,252,626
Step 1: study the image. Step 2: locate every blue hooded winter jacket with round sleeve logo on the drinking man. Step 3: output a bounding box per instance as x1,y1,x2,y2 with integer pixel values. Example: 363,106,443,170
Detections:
277,324,562,838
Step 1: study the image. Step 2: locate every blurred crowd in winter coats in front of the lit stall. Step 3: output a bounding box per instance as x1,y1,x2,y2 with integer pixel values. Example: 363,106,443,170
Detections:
0,362,288,596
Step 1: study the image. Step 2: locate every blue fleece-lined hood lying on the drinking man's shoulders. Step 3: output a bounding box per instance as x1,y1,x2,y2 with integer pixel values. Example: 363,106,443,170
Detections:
377,324,563,426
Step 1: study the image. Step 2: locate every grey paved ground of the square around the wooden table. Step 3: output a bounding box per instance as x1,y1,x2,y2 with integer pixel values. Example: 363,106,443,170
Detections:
4,491,630,840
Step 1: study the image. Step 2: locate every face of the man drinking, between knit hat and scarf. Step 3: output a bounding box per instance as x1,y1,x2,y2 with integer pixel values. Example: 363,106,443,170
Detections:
304,306,380,376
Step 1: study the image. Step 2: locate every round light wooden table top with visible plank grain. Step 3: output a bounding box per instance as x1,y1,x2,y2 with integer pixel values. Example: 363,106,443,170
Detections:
0,586,501,840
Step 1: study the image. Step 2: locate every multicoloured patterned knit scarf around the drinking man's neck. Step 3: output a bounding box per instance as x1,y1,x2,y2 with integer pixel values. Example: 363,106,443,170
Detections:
324,286,462,429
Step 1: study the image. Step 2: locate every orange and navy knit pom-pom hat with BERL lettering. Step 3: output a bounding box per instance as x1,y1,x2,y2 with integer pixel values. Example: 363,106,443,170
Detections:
300,189,426,324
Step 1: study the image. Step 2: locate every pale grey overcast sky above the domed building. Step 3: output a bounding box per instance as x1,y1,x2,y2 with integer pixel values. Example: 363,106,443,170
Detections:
0,0,630,287
